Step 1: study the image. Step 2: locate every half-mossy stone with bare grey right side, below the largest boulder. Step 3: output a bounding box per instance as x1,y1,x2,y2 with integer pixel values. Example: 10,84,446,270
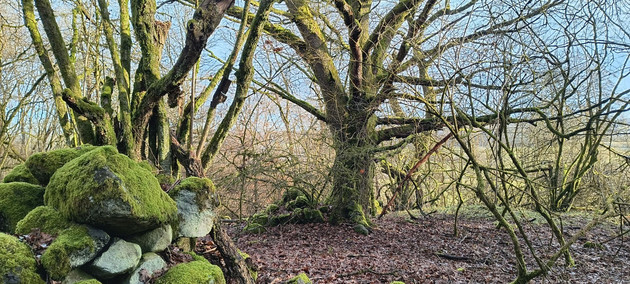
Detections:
42,224,110,280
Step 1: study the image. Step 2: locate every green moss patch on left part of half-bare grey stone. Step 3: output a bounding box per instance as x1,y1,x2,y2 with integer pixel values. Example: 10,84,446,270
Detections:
42,225,101,280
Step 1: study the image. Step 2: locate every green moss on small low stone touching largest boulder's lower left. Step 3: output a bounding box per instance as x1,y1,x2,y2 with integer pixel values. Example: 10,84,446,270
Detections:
15,206,72,235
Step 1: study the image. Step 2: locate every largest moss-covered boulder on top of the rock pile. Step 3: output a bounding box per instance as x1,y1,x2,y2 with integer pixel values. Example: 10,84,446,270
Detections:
44,146,177,236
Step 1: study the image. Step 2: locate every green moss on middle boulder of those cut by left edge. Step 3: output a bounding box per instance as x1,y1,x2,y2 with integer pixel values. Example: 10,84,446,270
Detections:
0,182,45,233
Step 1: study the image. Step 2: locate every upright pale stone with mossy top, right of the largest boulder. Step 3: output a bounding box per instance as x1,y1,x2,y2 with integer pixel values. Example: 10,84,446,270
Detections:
169,177,219,238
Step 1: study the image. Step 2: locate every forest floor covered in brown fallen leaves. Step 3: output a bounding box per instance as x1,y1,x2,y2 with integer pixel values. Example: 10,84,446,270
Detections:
228,209,630,284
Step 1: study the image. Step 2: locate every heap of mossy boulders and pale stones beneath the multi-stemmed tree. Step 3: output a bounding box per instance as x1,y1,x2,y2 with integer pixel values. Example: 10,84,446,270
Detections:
0,146,225,284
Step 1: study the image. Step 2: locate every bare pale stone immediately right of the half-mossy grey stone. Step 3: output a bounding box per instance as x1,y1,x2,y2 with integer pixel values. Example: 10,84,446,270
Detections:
85,238,142,279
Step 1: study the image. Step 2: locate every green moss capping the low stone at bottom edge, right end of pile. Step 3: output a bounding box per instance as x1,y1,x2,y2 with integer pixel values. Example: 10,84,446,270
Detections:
155,259,225,284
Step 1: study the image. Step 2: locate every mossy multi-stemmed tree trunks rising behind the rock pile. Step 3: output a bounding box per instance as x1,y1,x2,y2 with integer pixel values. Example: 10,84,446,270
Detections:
22,0,237,170
